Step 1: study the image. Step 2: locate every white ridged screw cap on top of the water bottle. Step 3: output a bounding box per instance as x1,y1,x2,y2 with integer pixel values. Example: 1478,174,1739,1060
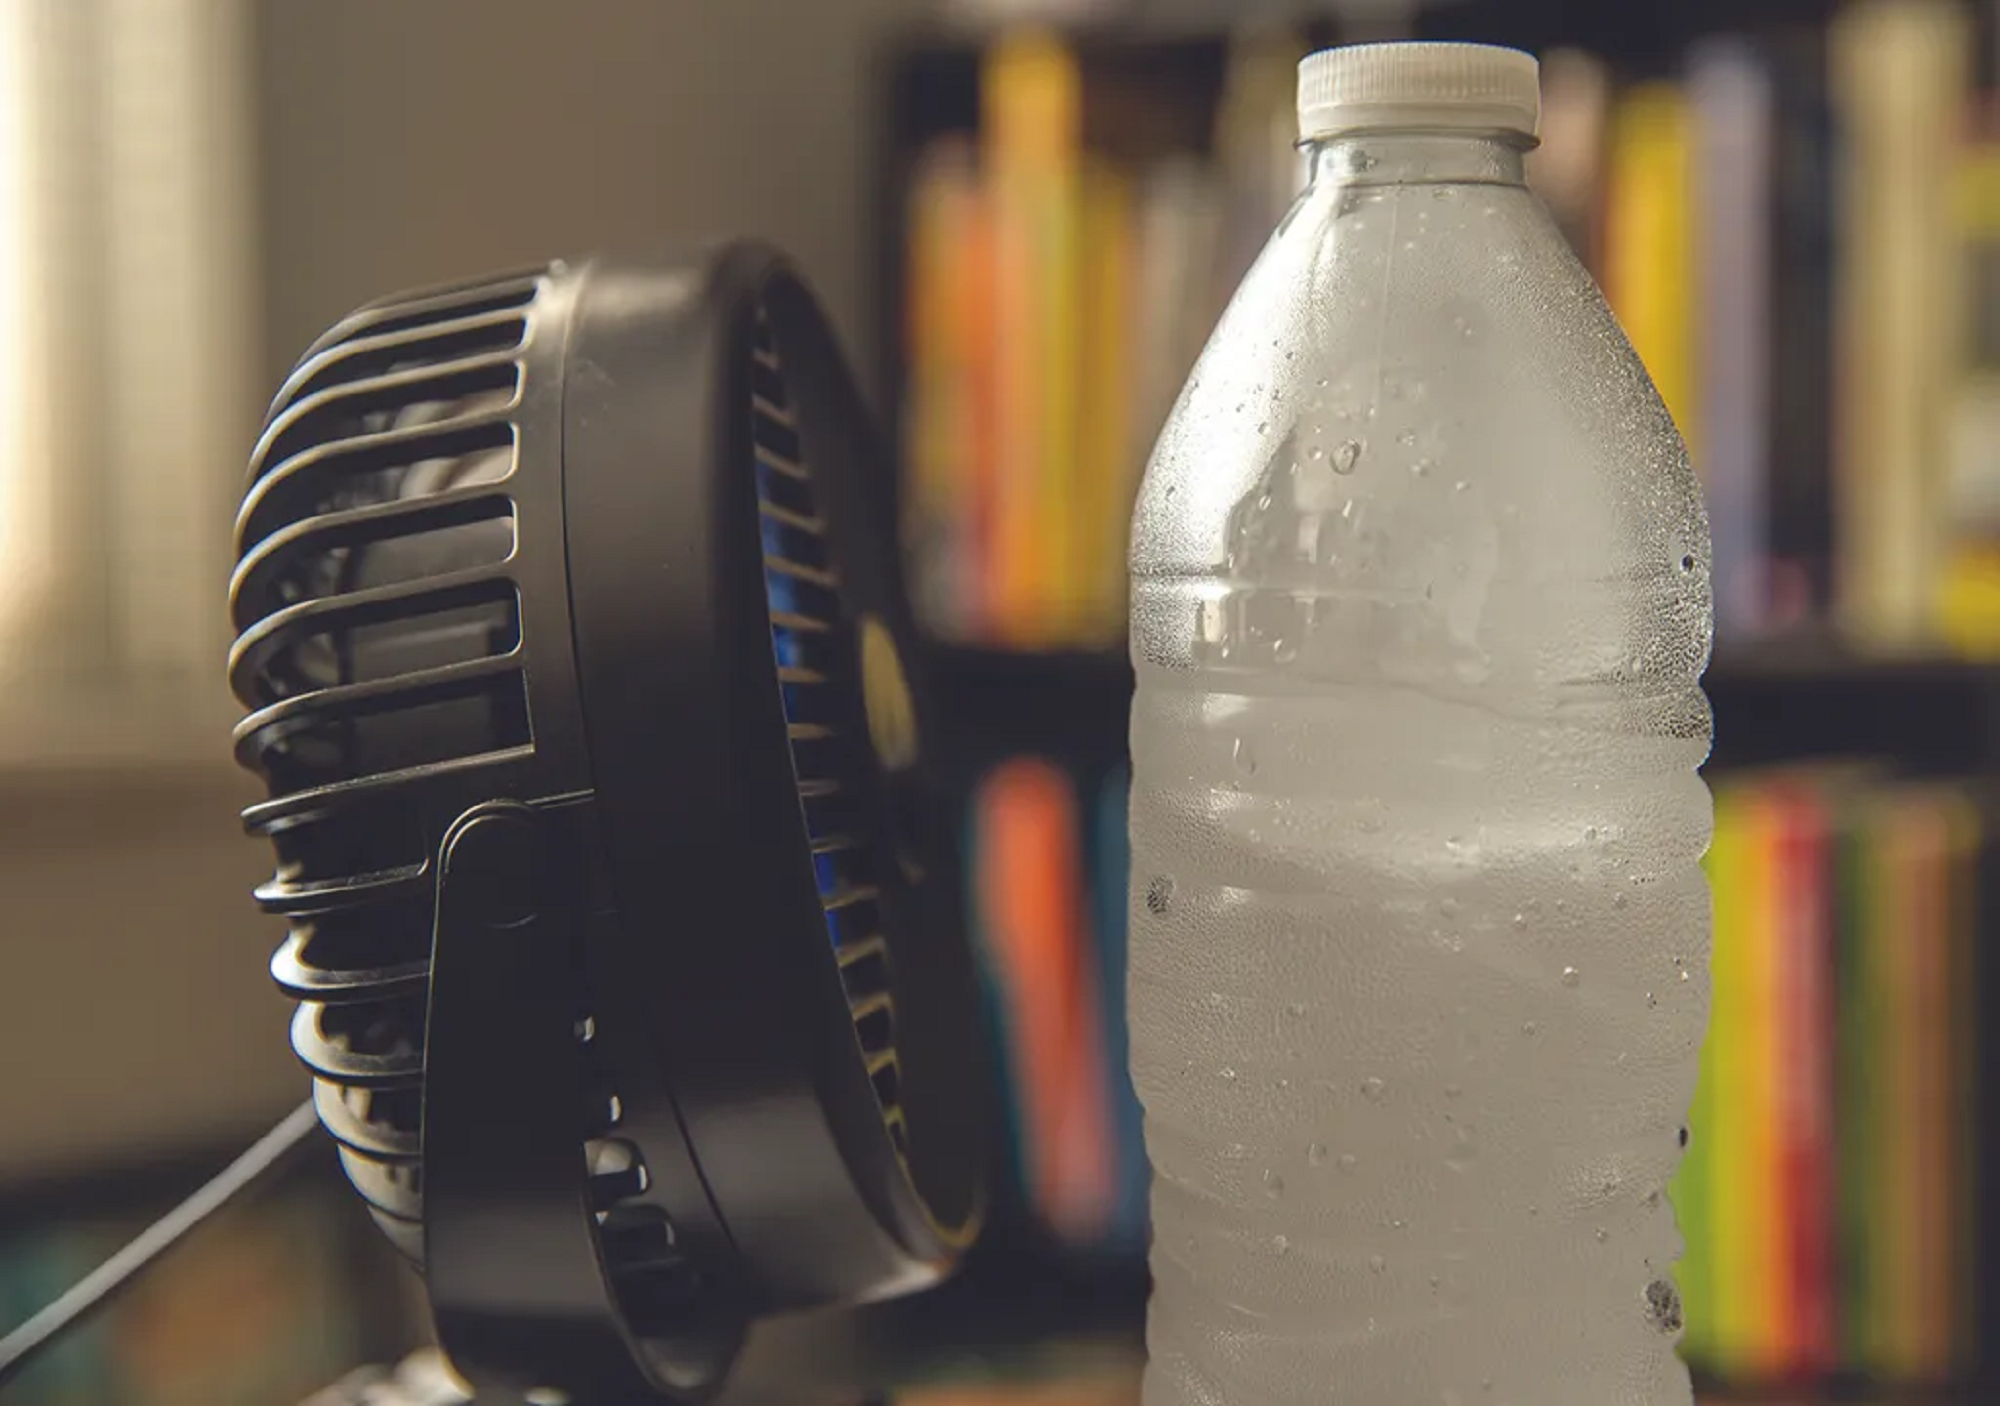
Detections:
1298,44,1542,142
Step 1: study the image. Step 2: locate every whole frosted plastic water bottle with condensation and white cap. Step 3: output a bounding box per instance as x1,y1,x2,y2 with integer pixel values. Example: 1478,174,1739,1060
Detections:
1130,44,1712,1406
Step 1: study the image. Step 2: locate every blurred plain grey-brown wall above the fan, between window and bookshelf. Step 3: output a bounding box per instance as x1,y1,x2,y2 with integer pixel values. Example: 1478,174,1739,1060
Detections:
258,0,934,396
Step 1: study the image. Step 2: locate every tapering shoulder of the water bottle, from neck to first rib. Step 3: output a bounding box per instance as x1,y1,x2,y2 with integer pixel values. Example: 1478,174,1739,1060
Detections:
1132,184,1710,708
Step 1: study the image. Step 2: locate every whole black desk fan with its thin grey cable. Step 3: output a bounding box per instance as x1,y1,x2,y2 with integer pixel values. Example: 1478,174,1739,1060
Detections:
0,246,986,1406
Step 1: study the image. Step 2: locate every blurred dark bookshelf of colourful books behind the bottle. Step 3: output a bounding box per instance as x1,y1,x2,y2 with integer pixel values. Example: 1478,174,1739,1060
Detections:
874,0,2000,1402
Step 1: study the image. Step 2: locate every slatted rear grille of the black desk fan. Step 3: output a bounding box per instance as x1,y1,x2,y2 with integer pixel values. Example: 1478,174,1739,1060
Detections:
230,270,644,1268
